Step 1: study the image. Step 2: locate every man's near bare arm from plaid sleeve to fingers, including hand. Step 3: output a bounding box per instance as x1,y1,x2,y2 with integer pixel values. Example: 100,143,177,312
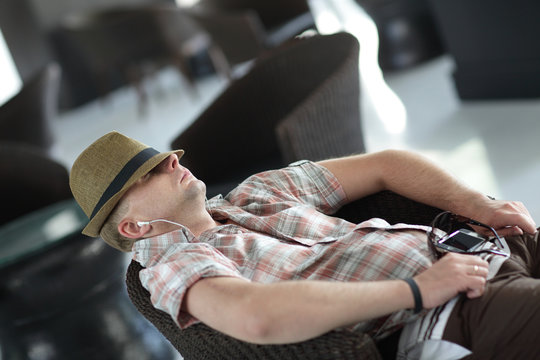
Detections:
182,254,488,344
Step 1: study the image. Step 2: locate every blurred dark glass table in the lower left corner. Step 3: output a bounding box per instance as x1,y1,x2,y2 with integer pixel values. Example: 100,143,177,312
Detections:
0,200,176,360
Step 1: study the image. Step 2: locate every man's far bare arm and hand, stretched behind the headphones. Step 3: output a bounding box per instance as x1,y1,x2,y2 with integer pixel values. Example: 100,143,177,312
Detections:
320,150,536,236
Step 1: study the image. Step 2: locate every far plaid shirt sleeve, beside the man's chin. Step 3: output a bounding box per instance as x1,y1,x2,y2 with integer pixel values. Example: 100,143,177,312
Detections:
227,160,347,214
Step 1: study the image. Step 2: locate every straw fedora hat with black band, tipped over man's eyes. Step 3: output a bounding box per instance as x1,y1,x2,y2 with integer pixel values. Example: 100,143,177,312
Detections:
69,131,184,241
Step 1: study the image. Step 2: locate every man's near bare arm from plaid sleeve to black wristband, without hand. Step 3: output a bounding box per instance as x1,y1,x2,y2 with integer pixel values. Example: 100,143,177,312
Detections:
182,278,414,343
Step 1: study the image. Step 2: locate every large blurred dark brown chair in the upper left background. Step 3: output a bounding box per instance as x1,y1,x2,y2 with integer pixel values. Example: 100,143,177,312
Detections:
51,4,230,111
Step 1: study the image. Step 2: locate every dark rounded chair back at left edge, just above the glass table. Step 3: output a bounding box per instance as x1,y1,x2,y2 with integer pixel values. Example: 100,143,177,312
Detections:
0,142,72,224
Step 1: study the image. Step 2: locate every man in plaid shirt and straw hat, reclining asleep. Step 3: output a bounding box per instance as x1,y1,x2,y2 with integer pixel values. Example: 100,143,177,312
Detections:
70,132,540,358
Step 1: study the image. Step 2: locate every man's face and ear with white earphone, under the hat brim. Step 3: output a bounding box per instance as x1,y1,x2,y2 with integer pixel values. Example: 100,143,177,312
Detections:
124,154,206,223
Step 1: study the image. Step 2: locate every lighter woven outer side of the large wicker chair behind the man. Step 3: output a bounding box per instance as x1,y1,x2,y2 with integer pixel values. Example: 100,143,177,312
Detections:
275,34,365,163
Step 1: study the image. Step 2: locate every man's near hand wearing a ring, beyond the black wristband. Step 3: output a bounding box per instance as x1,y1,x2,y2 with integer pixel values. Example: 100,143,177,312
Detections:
414,253,488,309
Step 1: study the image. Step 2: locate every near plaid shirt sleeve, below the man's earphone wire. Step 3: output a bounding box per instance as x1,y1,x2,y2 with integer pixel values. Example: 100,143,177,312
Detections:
139,243,242,329
